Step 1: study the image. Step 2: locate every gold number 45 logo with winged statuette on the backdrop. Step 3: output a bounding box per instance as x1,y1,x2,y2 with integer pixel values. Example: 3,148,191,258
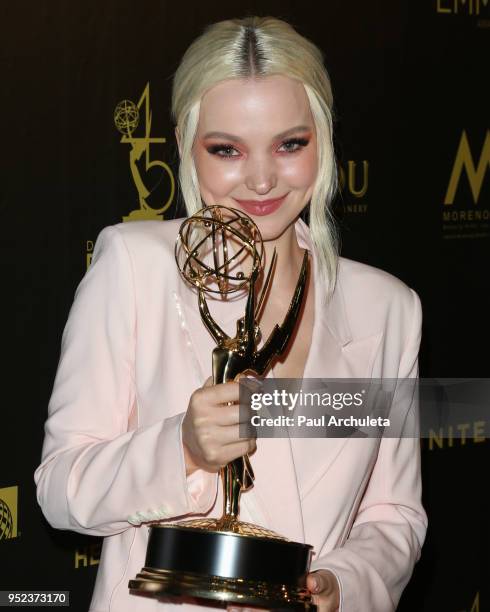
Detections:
114,83,175,221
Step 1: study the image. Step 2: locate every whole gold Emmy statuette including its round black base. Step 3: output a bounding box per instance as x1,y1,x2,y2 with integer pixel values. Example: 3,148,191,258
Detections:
129,206,316,610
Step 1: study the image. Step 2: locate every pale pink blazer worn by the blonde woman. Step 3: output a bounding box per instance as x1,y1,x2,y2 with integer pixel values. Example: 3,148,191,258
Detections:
34,214,427,612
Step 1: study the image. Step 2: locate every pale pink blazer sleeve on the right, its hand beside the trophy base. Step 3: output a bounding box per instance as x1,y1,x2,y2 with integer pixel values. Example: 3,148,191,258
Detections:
311,289,427,612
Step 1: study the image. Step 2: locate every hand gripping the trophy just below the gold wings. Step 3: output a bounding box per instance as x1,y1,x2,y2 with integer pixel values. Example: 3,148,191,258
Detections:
182,377,257,475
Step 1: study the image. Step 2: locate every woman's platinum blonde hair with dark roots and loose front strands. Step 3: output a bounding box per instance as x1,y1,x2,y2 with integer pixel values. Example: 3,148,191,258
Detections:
172,16,338,302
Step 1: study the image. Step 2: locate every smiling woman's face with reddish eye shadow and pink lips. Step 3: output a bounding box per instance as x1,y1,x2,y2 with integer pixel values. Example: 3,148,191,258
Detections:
188,75,318,240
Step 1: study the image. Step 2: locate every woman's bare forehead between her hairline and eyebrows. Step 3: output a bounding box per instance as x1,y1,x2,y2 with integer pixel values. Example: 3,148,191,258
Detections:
198,75,313,135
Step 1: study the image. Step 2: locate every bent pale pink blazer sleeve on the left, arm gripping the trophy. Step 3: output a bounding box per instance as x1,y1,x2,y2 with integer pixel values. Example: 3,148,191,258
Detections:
34,226,217,536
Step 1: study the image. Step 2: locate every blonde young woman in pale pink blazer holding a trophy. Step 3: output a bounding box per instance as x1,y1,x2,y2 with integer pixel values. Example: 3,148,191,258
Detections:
35,17,427,612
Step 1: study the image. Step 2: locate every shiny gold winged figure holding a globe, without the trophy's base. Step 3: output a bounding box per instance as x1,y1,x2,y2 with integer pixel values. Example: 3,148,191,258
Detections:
175,205,309,531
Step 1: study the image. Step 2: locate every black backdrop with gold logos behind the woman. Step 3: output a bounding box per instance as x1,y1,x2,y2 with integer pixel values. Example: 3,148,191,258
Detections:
0,0,490,612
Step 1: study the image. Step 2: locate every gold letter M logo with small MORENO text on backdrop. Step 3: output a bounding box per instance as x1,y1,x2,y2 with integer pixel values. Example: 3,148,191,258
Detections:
442,130,490,238
